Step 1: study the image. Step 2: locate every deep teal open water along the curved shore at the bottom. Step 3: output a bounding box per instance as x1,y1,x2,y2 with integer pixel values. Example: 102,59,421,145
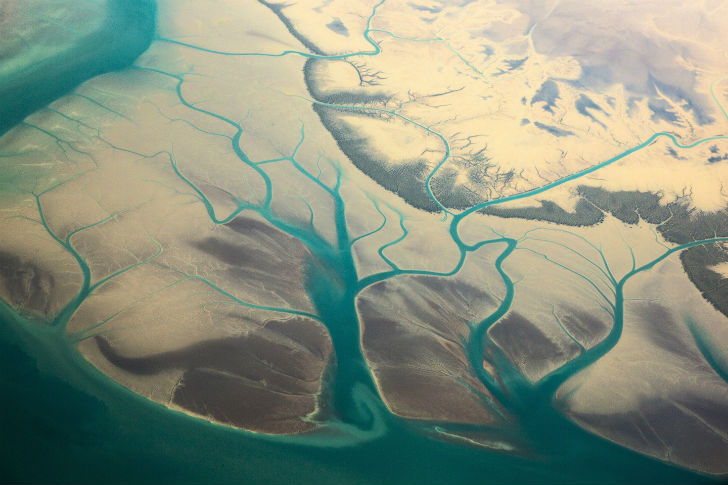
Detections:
0,305,717,484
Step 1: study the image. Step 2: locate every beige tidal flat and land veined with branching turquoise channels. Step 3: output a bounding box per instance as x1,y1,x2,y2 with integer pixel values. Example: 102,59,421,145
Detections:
0,0,728,475
